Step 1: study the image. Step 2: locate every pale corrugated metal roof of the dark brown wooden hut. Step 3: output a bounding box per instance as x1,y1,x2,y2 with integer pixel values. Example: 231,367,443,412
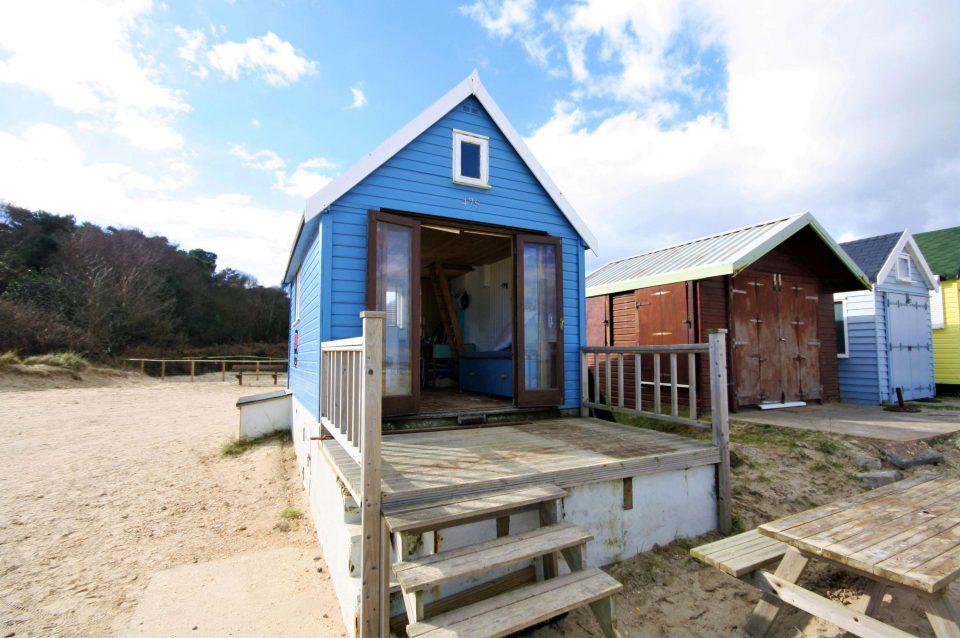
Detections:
587,213,870,297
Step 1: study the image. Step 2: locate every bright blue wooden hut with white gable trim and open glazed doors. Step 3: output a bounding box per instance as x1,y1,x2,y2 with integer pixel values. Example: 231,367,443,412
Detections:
284,72,596,419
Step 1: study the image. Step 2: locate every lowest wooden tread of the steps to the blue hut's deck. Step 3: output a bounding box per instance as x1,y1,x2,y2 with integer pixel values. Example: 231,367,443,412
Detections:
407,568,623,638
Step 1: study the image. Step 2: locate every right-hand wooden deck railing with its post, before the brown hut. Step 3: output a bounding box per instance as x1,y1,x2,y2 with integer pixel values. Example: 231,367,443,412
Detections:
580,330,732,533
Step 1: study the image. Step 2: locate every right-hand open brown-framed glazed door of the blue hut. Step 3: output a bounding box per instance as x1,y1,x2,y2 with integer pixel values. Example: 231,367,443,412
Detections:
514,235,563,406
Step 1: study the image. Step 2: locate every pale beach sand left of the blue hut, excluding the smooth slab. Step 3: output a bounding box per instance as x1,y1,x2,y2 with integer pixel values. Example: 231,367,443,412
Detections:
0,375,343,636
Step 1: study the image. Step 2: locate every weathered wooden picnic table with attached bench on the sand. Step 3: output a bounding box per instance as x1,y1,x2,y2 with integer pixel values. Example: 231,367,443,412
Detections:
694,477,960,638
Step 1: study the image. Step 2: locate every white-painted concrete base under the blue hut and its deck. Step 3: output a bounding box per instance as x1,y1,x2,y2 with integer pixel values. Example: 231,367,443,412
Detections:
292,397,717,638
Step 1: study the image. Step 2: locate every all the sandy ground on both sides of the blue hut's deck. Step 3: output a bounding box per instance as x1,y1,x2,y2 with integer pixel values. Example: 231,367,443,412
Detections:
0,364,960,638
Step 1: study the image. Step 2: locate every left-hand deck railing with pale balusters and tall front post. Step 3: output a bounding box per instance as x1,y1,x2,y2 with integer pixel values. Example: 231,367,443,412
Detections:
320,311,390,638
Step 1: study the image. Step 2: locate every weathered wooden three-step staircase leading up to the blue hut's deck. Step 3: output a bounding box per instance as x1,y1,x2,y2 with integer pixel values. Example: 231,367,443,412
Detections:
385,485,623,638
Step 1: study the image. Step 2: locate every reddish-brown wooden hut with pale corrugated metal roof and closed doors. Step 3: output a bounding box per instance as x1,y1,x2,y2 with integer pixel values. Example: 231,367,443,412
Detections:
587,213,870,408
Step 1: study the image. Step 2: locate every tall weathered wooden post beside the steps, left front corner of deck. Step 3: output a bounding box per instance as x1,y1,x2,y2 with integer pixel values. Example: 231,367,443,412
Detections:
360,310,390,638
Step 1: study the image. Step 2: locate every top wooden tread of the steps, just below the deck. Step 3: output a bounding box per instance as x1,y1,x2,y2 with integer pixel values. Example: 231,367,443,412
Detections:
385,484,567,533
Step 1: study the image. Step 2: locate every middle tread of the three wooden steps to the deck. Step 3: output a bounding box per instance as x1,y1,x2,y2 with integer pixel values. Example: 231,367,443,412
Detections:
393,523,593,594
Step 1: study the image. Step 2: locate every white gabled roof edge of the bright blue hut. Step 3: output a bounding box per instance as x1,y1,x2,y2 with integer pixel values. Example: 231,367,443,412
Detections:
304,71,597,250
